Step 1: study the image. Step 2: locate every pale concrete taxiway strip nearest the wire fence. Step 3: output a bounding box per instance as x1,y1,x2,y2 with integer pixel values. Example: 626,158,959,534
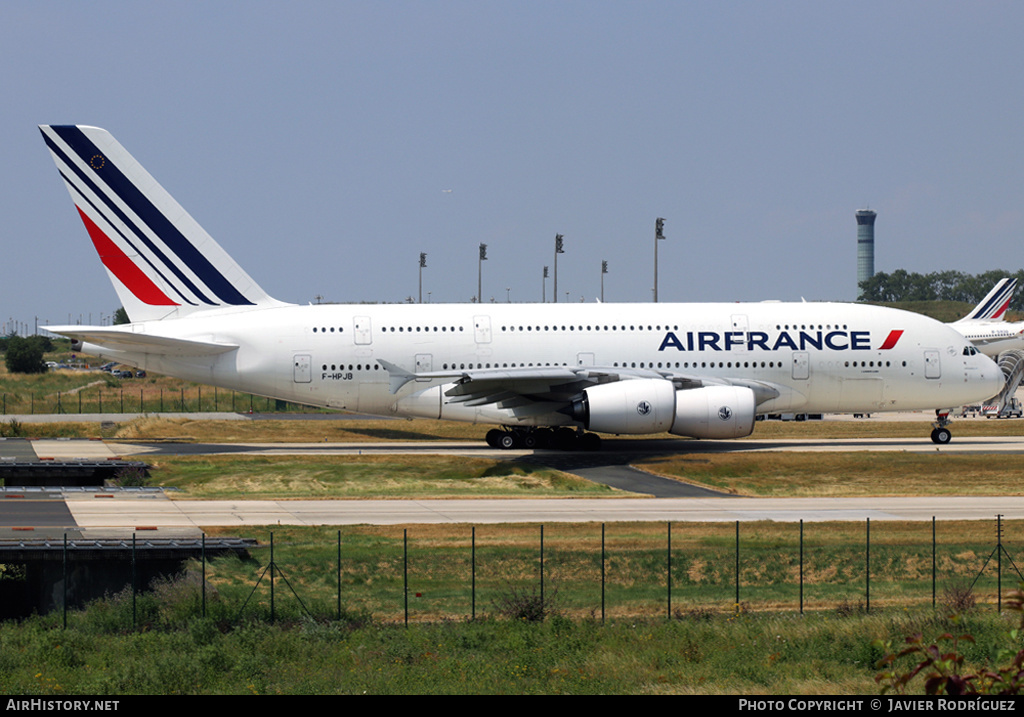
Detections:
44,494,1024,534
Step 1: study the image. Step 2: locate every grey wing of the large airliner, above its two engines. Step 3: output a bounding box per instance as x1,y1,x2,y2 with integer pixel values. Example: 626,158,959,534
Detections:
378,359,779,414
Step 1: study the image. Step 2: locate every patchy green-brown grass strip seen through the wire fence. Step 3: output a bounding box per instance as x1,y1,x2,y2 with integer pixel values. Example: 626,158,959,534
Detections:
8,516,1024,623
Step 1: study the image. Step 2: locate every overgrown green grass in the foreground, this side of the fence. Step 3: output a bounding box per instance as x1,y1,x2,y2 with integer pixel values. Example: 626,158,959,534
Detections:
0,581,1020,695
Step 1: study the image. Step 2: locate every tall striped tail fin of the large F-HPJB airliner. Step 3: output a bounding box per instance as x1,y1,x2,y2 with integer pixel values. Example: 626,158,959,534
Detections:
39,125,284,322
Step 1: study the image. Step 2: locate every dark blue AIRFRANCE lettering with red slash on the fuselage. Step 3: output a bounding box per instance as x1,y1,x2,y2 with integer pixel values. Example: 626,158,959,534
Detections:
657,330,888,351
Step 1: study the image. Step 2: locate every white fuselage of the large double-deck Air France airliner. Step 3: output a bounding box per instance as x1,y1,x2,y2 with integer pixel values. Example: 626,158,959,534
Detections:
75,302,1002,425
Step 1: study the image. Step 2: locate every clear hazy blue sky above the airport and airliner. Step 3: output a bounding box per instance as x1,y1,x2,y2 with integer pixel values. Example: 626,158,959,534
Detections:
0,0,1024,328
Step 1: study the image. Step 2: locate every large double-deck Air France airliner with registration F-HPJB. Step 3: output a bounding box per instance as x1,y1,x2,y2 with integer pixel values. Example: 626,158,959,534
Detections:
40,126,1002,448
